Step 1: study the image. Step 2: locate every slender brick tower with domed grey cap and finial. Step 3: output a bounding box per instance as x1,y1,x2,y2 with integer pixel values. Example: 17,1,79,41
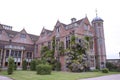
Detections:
92,11,106,69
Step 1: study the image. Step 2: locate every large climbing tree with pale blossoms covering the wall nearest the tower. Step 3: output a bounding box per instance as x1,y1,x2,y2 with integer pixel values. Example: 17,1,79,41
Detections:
67,36,88,72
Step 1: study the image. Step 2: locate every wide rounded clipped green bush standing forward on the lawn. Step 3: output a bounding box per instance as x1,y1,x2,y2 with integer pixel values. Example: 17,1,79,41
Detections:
36,64,52,75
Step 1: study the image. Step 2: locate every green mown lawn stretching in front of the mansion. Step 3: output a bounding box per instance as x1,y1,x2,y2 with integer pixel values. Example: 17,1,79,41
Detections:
0,71,120,80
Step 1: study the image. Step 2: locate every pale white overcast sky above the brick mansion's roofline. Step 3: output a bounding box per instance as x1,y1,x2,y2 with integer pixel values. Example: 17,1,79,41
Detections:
0,0,120,59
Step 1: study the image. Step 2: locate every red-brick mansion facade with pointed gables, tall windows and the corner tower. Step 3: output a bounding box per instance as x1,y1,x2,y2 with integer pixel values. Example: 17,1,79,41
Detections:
0,16,106,71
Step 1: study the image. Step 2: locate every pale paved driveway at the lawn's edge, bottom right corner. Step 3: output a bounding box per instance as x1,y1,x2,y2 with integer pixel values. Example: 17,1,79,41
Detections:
80,74,120,80
